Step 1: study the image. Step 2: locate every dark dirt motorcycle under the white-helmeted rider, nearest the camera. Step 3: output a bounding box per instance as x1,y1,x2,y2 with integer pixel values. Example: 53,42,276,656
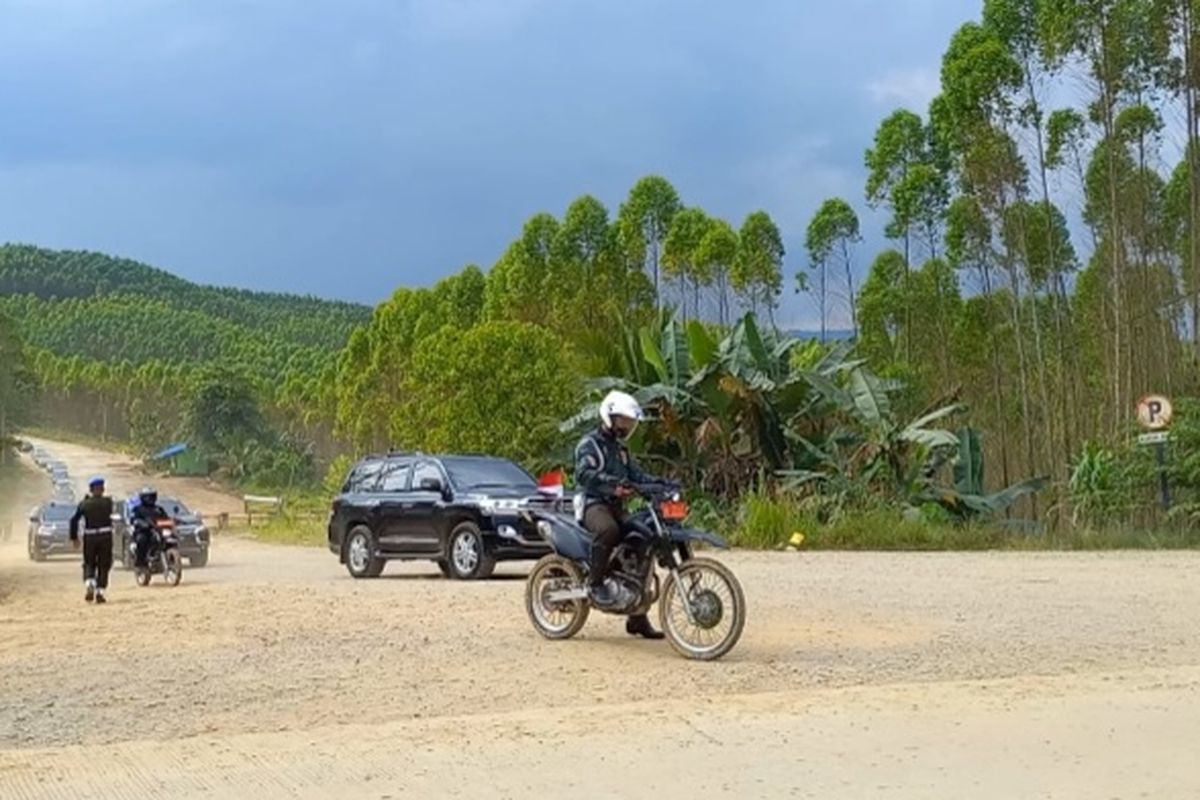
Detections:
526,483,746,661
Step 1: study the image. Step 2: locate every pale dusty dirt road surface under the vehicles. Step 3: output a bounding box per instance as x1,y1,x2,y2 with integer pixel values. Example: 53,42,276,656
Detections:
0,445,1200,800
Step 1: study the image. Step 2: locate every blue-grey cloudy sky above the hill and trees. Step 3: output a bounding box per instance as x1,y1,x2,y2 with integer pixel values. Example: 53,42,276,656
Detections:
0,0,964,325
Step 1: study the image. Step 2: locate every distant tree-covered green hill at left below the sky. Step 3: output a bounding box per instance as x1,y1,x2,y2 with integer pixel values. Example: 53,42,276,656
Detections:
0,245,371,361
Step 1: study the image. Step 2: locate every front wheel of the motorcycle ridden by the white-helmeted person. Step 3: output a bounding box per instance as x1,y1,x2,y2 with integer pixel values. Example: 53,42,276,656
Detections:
659,558,746,661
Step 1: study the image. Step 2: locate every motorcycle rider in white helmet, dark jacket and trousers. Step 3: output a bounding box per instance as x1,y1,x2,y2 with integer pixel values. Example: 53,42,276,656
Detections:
575,391,662,639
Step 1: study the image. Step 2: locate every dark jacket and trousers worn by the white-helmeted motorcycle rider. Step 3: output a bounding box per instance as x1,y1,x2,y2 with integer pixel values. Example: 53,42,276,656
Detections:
575,428,654,585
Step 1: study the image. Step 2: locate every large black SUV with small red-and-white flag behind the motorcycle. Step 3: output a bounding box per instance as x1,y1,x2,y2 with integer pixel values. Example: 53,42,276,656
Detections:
329,453,560,579
